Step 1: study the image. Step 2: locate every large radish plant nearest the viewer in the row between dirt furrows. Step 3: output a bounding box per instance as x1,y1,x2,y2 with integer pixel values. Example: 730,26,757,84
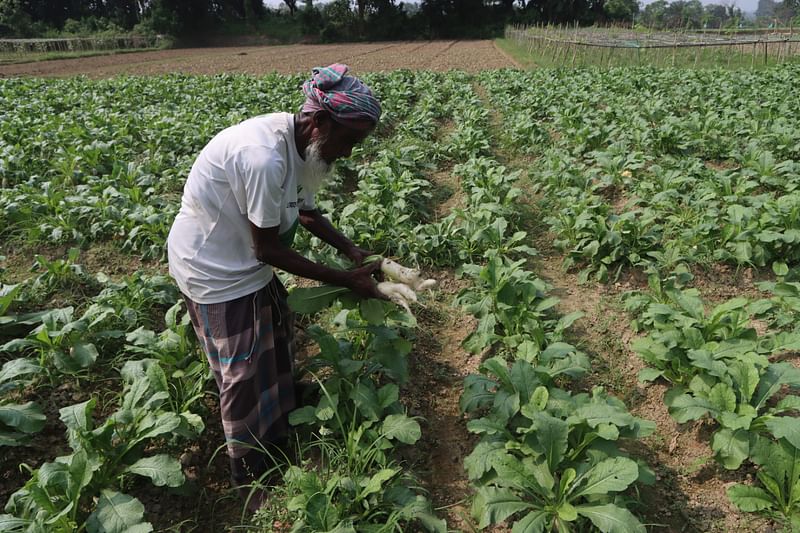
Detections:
464,381,655,532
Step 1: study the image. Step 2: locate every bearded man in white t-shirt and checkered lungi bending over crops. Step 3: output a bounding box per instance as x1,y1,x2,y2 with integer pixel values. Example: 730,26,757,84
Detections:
167,64,382,502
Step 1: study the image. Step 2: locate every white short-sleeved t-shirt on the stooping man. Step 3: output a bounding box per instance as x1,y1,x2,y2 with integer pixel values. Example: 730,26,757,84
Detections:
167,113,314,304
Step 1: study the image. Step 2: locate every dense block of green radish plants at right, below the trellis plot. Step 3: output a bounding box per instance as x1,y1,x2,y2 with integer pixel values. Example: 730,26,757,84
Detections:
481,66,800,281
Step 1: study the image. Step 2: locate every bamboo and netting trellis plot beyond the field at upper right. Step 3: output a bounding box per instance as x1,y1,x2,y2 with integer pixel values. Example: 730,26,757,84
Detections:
505,25,800,67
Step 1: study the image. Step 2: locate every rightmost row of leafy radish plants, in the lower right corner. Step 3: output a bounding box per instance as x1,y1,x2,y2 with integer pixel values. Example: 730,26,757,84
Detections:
626,272,800,528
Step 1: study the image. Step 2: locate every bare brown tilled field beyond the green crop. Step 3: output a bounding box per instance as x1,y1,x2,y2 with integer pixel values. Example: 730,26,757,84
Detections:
0,40,516,78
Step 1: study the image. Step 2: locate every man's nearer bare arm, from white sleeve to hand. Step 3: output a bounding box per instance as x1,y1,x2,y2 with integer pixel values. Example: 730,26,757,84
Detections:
250,222,386,300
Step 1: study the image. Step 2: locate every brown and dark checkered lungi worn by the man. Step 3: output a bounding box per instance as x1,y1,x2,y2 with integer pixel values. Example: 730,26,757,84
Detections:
184,276,295,486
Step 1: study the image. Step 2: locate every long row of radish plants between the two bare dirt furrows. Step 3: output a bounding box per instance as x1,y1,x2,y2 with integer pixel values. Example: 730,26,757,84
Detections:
440,81,655,532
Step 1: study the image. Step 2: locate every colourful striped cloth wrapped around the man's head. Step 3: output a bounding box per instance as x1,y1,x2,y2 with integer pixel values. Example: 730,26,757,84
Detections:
302,63,381,128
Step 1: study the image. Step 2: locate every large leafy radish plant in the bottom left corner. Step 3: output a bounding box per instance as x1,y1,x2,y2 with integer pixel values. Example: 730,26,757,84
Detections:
2,364,203,533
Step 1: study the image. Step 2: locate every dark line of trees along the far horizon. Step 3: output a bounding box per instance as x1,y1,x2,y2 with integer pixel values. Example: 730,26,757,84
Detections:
0,0,800,41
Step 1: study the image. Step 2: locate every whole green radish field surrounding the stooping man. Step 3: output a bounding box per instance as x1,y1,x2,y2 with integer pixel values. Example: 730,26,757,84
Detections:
0,63,800,532
